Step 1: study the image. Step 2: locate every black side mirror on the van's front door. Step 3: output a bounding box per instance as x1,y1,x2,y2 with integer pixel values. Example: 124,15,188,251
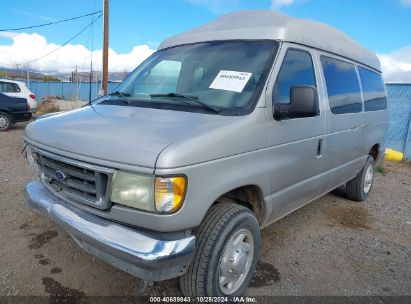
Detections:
273,86,318,120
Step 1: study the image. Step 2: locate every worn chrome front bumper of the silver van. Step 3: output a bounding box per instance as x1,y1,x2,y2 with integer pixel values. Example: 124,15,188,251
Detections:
25,181,195,281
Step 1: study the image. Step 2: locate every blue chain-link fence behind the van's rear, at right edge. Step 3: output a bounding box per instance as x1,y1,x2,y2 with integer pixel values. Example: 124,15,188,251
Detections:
386,84,411,160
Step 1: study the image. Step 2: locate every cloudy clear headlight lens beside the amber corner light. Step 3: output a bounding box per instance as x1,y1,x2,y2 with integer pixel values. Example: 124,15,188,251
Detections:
111,171,154,211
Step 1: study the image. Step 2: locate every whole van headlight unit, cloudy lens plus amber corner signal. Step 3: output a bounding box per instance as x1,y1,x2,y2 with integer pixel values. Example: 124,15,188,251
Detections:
111,171,187,213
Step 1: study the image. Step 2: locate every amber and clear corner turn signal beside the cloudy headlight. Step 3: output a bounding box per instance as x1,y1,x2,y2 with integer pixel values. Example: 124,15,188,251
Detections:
154,176,187,213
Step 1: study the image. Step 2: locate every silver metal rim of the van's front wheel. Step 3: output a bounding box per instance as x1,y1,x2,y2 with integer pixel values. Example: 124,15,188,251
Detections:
219,229,254,295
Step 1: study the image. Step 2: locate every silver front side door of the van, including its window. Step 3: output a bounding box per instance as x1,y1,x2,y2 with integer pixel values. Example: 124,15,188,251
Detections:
266,43,325,220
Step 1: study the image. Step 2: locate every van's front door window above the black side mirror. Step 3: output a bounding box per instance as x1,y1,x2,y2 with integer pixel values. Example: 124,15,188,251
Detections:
273,49,316,104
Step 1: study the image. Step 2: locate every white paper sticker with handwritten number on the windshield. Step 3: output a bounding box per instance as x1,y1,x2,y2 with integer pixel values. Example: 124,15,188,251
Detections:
210,70,253,93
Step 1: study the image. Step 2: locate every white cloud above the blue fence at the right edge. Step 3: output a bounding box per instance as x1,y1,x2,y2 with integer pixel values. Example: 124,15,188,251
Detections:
377,45,411,83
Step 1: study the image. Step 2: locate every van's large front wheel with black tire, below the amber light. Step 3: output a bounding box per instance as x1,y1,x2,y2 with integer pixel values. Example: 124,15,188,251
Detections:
180,203,261,297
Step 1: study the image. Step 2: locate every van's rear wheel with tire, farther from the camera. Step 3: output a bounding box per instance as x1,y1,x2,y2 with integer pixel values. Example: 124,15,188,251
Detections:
346,156,374,202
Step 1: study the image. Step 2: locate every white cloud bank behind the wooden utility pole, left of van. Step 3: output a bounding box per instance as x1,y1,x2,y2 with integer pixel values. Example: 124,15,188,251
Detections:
0,32,154,72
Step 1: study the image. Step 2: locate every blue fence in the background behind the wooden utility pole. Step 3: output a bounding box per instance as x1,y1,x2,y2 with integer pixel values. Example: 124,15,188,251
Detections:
29,81,119,102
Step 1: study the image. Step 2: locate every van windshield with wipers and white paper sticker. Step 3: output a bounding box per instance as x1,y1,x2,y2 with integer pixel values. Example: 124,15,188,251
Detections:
101,40,278,115
